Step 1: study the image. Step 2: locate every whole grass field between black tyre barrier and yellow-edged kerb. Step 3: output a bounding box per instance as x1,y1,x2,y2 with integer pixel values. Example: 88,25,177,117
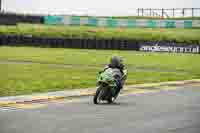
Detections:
0,47,200,96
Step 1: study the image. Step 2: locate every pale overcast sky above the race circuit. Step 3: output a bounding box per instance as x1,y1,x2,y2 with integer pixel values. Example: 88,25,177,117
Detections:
2,0,200,16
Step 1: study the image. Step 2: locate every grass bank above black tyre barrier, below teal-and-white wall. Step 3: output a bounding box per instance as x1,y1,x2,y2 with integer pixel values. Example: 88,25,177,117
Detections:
0,24,200,44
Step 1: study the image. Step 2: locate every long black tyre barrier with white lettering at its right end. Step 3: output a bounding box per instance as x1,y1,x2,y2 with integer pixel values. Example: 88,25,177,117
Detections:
0,35,200,53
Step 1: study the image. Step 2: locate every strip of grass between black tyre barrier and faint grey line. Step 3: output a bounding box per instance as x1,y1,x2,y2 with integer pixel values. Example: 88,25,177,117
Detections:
0,47,200,71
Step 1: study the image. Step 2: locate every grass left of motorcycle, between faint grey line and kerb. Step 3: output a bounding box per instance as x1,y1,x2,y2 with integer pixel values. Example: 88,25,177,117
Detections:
0,64,98,96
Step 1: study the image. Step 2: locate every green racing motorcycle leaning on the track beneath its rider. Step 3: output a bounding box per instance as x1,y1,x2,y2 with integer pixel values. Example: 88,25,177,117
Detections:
93,68,127,104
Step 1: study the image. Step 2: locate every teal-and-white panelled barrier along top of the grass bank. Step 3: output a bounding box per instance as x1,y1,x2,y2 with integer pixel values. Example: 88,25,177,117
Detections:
44,16,200,28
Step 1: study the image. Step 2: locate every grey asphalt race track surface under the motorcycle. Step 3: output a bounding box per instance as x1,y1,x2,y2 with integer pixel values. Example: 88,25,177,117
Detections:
0,86,200,133
